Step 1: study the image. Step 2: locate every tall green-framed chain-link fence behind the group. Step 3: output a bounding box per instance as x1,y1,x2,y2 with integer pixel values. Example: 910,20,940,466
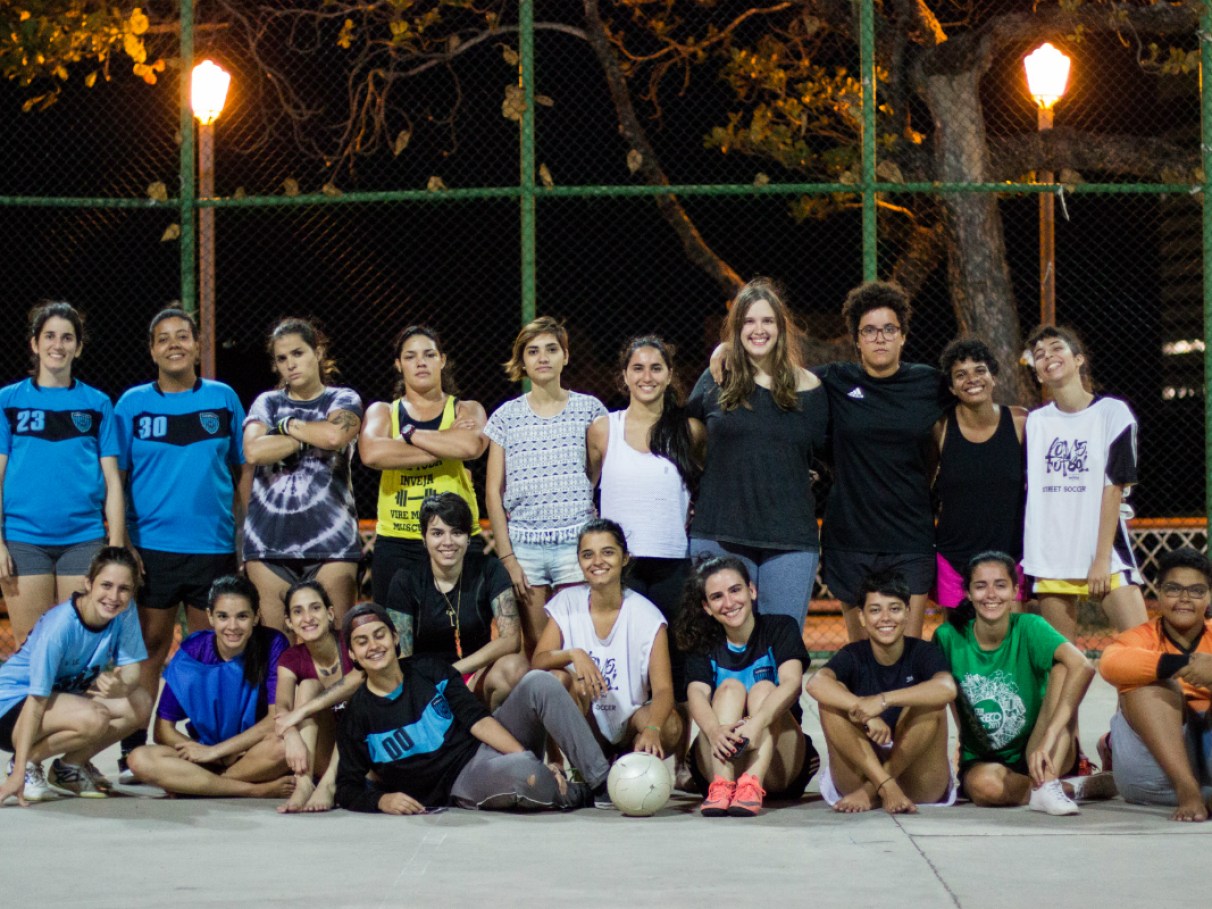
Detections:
0,0,1208,652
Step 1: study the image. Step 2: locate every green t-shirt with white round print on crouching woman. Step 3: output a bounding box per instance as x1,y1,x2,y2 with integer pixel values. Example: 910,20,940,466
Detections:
934,613,1065,765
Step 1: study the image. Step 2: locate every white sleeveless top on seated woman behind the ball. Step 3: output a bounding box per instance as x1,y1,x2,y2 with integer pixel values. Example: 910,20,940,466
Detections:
545,584,665,744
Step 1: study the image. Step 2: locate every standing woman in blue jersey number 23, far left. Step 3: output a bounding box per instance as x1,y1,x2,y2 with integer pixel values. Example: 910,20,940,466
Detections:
0,302,126,646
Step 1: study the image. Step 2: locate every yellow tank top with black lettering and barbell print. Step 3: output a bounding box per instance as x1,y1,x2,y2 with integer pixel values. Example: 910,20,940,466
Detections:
375,395,480,539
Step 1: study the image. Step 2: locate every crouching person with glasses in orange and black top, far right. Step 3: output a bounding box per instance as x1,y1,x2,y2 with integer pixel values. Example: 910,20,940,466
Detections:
1098,548,1212,821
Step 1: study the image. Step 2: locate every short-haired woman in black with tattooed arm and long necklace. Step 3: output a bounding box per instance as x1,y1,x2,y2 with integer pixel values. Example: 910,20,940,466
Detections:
385,492,530,710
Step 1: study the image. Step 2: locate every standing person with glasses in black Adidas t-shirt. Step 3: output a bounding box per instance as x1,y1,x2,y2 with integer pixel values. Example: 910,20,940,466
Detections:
818,281,947,641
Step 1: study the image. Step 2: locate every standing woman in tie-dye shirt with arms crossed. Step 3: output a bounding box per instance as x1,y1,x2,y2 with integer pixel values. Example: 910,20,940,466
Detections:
244,319,362,630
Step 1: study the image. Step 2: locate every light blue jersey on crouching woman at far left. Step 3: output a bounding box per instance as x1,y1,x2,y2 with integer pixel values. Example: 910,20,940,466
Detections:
0,600,148,716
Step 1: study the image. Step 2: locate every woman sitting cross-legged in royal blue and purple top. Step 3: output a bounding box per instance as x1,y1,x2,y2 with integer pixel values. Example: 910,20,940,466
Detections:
127,574,295,799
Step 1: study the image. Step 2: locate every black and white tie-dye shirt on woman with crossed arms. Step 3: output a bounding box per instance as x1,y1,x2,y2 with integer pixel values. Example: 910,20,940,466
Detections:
244,387,362,561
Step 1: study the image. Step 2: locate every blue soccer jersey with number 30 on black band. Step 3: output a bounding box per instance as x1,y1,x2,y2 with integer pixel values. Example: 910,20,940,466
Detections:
114,379,244,555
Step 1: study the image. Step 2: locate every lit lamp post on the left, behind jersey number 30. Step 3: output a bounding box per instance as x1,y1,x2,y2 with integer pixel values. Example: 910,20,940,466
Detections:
189,59,231,378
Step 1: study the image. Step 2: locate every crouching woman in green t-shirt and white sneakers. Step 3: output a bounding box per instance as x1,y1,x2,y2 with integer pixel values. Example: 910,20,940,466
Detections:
934,553,1115,814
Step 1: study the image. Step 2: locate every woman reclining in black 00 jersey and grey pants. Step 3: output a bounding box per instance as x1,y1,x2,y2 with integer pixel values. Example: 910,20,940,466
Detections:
337,602,610,814
